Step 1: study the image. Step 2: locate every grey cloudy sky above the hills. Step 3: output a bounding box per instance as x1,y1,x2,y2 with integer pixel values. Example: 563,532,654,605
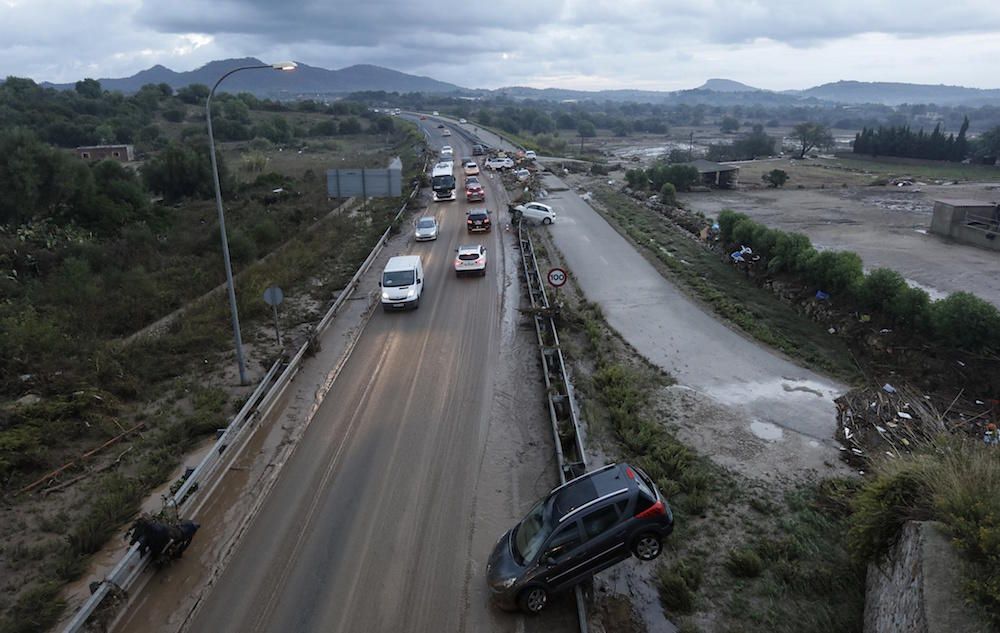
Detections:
0,0,1000,90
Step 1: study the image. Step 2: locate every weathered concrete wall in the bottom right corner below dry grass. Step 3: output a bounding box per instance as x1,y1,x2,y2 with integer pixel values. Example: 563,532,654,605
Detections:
864,522,991,633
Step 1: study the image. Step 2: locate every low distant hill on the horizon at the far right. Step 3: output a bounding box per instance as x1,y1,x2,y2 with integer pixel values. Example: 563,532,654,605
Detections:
789,81,1000,105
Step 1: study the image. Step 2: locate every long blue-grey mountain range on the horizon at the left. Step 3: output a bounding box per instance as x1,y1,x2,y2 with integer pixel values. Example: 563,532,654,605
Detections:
43,57,462,96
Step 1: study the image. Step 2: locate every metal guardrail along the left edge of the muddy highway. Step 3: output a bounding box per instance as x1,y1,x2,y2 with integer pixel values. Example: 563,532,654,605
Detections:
63,159,427,633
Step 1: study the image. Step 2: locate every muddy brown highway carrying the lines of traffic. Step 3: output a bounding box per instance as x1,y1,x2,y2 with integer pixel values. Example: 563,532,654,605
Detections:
117,122,575,633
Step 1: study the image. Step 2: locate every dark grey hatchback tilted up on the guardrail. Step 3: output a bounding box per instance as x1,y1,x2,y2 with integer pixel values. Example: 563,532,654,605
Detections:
486,464,674,613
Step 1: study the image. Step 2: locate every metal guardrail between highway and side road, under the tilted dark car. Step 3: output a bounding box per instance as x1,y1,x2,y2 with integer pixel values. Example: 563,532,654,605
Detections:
517,222,587,633
